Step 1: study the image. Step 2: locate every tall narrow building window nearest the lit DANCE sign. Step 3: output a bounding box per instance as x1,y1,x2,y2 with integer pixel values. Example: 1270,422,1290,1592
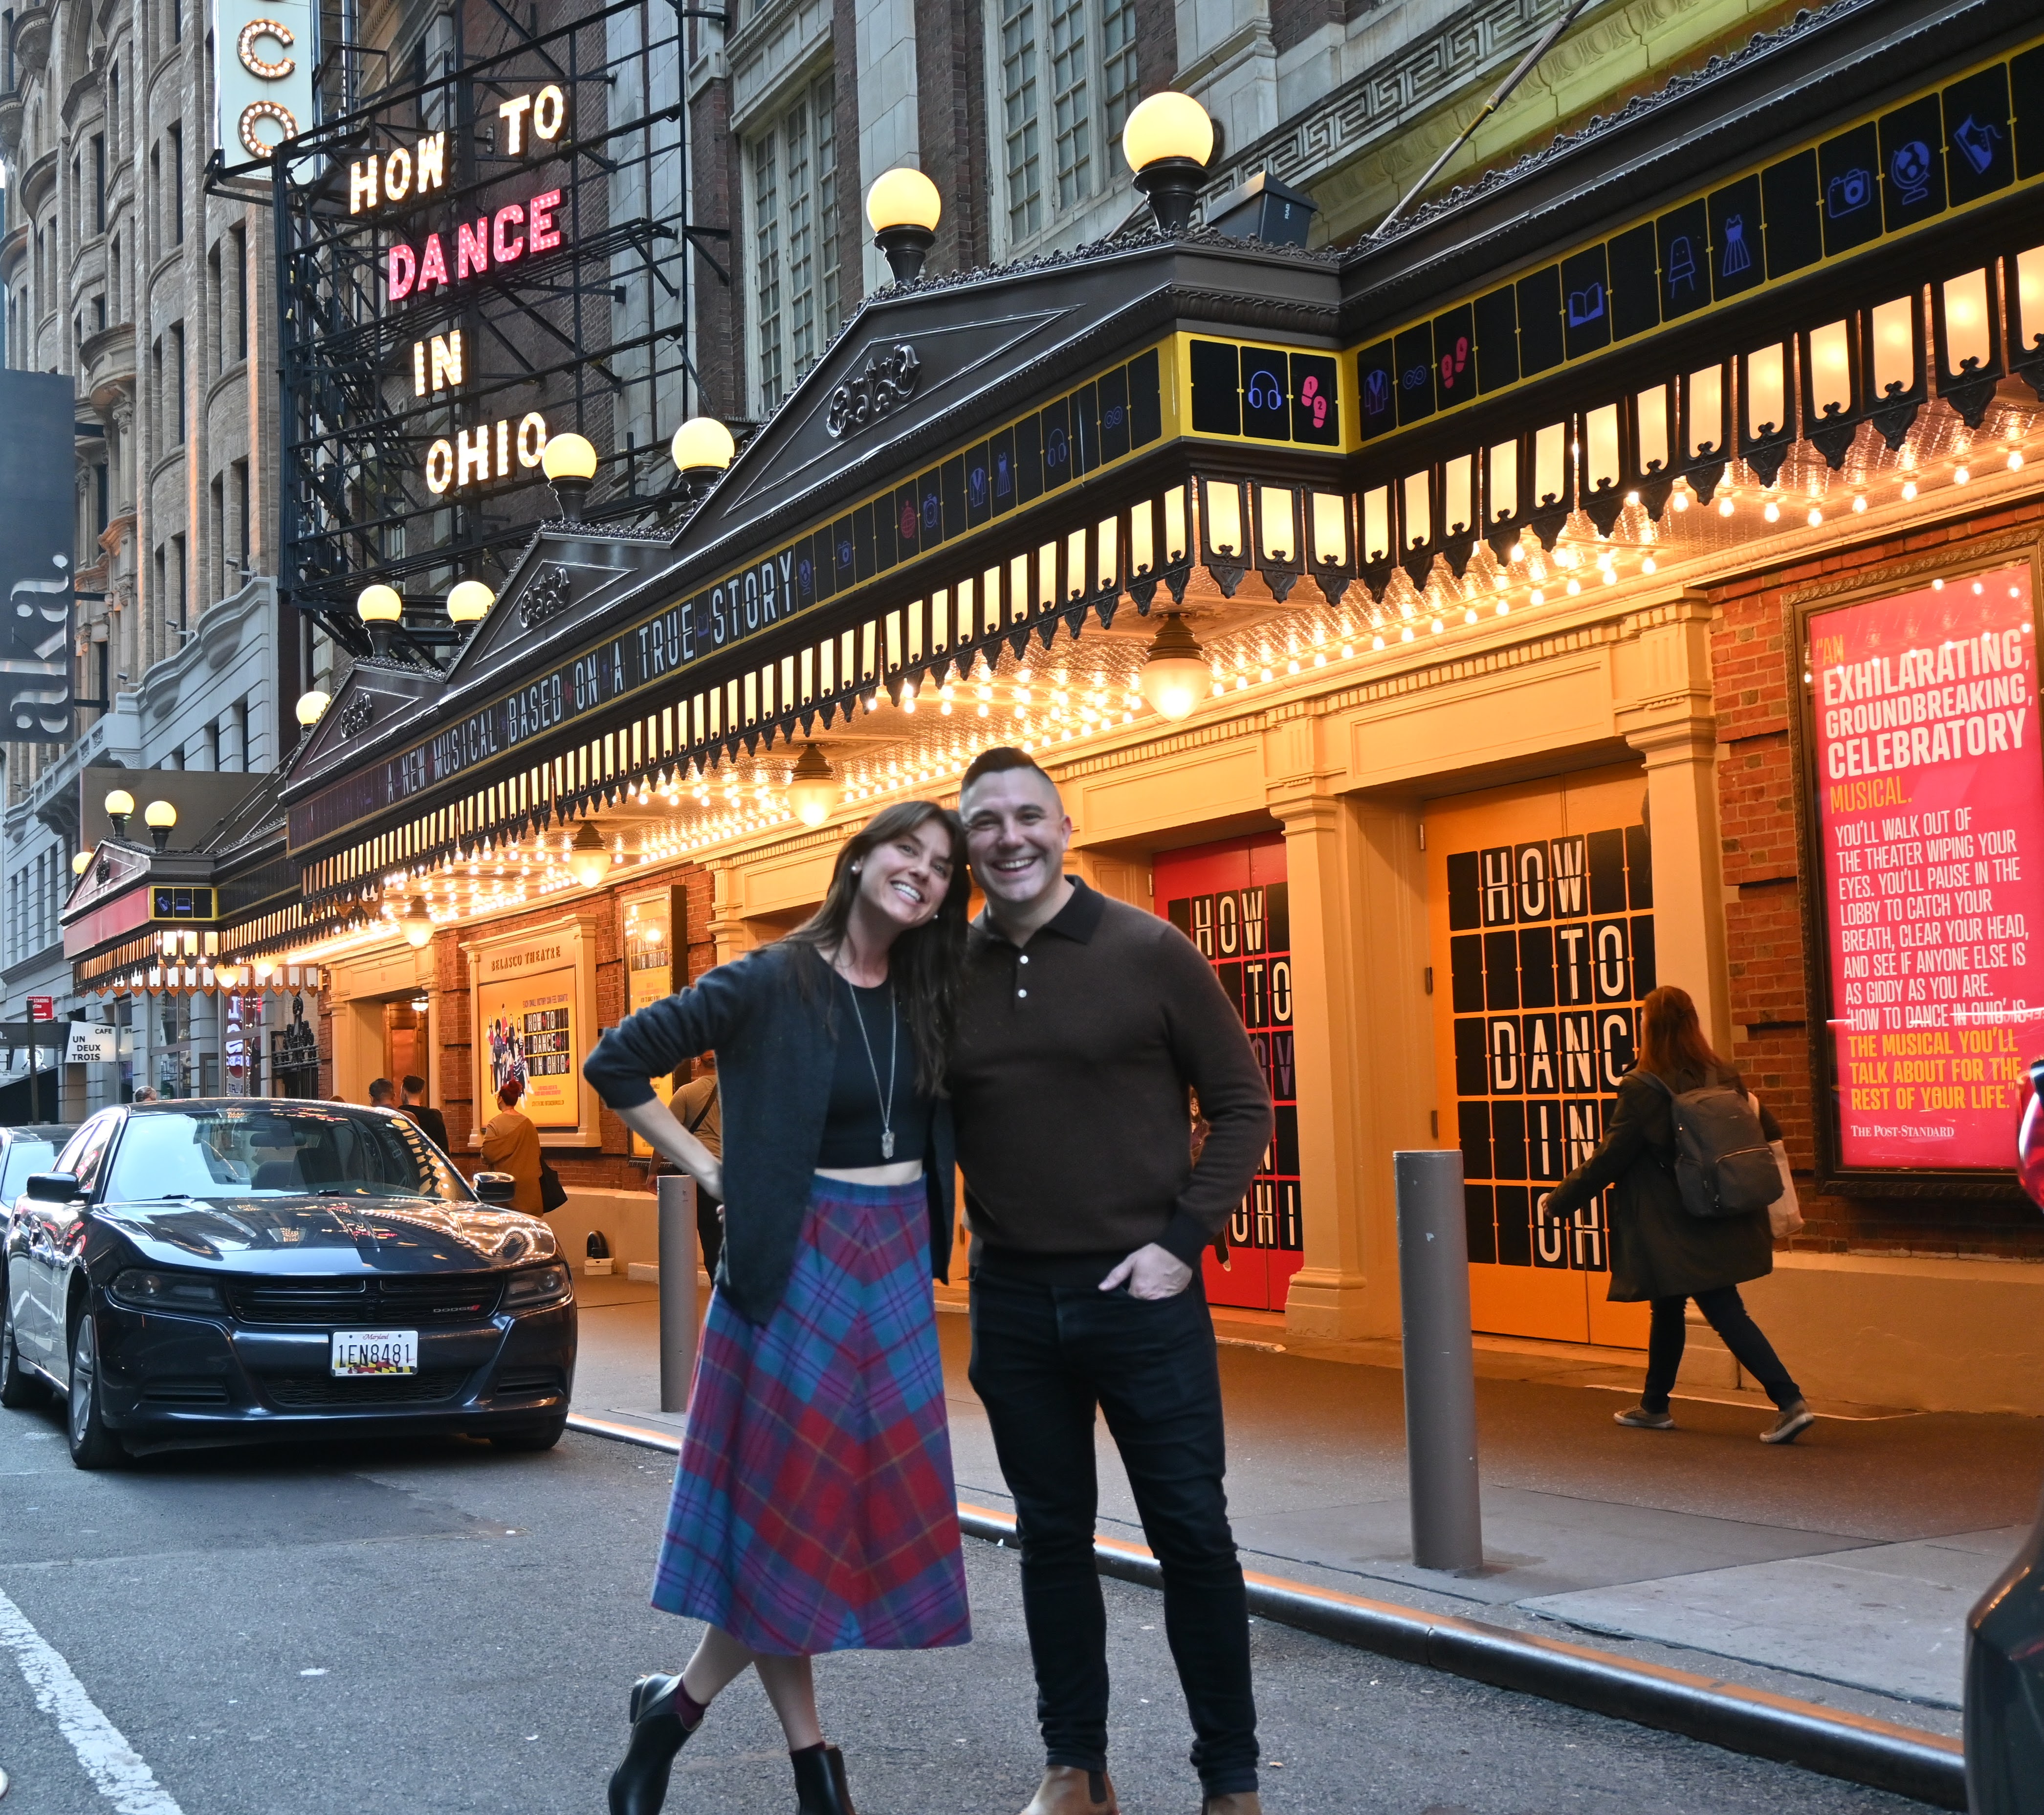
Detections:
746,76,838,411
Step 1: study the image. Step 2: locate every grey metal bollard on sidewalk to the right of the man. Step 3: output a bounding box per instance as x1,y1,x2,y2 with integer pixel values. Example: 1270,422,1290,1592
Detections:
1392,1149,1484,1570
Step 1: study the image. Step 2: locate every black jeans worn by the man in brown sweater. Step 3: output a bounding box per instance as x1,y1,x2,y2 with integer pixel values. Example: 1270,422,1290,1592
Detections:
971,1273,1257,1796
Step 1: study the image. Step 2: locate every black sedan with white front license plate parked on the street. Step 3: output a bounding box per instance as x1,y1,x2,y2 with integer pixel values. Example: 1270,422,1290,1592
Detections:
0,1098,574,1467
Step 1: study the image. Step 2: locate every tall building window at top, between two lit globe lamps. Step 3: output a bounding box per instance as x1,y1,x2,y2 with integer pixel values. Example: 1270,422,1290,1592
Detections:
1000,0,1137,241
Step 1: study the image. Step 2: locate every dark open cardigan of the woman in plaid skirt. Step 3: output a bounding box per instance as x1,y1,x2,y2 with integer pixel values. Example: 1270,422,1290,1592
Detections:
583,944,957,1323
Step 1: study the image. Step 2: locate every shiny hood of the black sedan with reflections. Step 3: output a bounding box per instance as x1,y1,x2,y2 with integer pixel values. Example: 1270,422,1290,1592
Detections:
94,1195,556,1273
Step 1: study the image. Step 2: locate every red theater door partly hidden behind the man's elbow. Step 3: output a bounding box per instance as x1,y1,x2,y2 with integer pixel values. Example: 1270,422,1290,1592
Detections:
1151,832,1304,1310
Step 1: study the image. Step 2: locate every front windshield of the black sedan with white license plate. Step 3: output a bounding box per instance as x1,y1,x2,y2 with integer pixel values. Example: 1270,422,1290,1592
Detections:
102,1106,474,1204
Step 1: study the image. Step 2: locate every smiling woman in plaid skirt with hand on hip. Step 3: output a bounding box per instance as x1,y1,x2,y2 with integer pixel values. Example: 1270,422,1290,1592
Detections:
583,801,971,1815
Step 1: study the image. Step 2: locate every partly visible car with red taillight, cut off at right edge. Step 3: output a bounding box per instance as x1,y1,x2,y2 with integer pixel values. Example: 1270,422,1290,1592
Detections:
1966,1059,2044,1815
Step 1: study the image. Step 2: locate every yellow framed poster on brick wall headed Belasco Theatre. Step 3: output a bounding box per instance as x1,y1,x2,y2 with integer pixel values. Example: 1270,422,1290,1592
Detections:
464,916,601,1147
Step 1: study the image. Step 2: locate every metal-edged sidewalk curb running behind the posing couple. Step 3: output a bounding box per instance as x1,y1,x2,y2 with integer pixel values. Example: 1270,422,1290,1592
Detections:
568,1415,1966,1811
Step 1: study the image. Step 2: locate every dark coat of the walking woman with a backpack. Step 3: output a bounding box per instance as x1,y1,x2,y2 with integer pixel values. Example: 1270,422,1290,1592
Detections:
1547,1071,1782,1304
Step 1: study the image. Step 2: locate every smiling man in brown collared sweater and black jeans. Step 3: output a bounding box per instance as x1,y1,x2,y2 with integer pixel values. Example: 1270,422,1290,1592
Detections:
950,748,1272,1815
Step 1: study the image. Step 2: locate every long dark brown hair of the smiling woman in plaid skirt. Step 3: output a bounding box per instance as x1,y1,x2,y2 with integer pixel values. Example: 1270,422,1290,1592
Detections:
785,801,973,1096
